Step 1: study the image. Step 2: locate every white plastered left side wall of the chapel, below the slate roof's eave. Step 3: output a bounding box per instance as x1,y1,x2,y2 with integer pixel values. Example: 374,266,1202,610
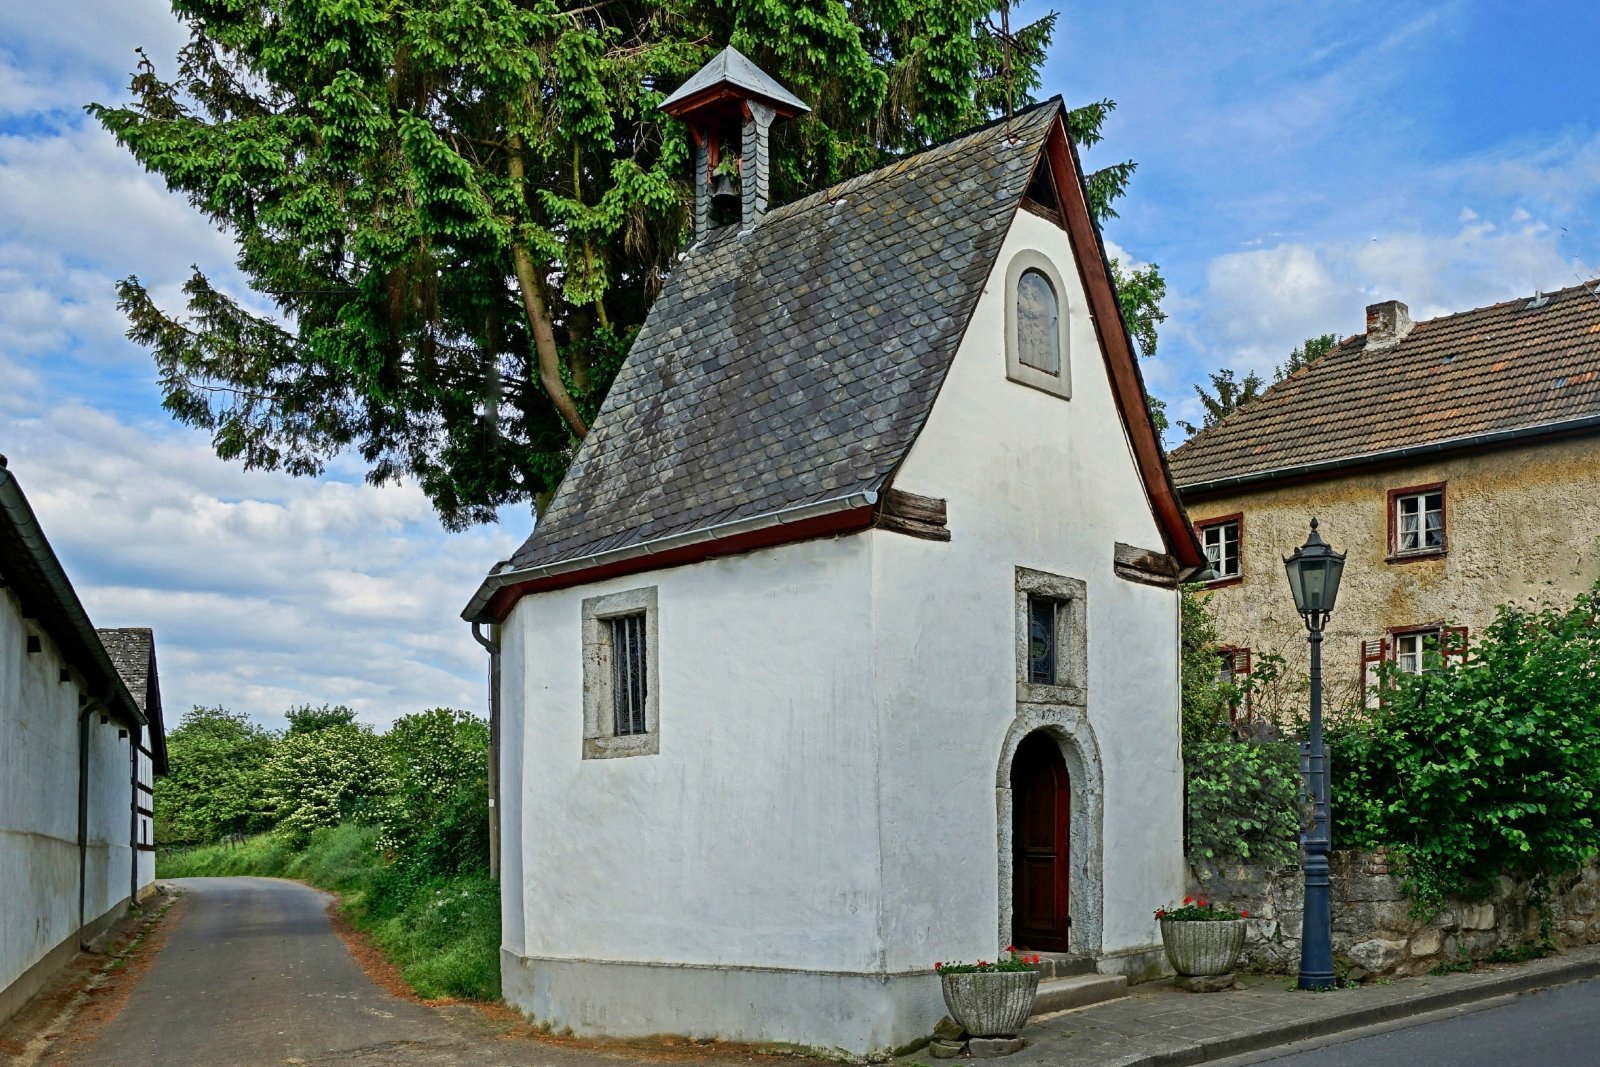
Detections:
501,536,882,973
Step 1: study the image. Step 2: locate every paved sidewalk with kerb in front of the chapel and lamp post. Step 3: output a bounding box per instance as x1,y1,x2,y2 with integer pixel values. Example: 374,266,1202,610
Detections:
985,945,1600,1067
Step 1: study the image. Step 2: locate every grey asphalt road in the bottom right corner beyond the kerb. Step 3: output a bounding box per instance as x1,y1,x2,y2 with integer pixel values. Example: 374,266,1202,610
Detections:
1230,981,1600,1067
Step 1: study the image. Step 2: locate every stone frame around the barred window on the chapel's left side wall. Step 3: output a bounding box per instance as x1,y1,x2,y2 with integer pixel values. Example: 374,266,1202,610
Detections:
582,585,661,760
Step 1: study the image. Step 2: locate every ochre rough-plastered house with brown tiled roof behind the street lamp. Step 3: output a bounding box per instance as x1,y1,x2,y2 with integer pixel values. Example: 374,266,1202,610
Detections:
1171,285,1600,713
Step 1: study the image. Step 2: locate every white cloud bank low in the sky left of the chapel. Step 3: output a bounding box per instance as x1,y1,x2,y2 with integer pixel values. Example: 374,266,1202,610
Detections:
5,405,517,723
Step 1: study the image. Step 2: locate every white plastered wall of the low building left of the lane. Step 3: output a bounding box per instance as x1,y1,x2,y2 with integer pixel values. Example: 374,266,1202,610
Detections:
0,590,133,1017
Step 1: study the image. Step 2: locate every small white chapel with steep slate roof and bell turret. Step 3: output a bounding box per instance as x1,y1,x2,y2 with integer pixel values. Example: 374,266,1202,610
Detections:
464,50,1205,1054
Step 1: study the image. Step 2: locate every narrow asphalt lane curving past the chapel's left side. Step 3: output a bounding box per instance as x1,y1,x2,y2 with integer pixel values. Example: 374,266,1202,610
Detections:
42,878,771,1067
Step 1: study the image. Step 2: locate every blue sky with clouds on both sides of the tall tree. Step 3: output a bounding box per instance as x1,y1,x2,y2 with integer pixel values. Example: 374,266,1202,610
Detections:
0,0,1600,725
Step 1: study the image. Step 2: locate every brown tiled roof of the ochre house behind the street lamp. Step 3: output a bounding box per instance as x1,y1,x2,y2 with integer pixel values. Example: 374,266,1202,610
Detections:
1168,285,1600,491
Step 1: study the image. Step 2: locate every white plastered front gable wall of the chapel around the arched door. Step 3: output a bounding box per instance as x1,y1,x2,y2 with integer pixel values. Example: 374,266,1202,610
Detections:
874,211,1184,969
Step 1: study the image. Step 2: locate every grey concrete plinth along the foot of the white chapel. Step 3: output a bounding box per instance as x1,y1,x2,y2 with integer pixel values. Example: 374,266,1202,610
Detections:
501,949,944,1059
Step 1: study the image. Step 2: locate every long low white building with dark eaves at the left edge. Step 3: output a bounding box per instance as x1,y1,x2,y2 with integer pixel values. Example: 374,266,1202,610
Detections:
0,458,160,1019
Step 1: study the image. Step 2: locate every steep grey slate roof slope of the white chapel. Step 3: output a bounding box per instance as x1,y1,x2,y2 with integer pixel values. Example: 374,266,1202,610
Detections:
499,101,1061,569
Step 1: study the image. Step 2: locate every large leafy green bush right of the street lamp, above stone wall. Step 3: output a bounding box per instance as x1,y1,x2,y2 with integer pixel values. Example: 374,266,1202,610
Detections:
1328,587,1600,909
